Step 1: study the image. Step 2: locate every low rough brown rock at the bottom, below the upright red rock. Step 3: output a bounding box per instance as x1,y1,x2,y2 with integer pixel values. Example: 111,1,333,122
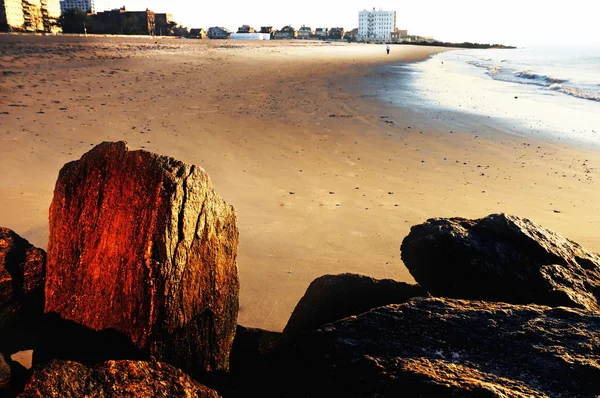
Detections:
19,361,219,398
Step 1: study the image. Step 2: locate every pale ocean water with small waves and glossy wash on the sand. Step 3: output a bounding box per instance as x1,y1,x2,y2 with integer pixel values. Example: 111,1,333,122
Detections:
383,47,600,148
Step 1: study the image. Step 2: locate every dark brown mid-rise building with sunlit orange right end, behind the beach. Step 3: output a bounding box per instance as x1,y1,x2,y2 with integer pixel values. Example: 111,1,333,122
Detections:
90,8,156,35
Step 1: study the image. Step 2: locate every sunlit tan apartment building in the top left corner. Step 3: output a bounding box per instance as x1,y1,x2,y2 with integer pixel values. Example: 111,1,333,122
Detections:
0,0,61,33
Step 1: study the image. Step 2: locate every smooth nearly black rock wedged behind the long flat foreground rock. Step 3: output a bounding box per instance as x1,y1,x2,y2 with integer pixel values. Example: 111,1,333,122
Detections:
283,274,428,336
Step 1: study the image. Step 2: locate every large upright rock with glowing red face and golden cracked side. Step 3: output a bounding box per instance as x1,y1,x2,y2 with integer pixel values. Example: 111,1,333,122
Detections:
45,142,239,372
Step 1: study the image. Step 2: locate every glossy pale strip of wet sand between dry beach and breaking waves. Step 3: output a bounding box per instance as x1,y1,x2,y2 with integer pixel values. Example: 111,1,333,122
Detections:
380,49,600,150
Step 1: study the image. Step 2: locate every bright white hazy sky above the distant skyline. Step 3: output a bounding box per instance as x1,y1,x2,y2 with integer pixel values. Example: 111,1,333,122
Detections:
101,0,600,45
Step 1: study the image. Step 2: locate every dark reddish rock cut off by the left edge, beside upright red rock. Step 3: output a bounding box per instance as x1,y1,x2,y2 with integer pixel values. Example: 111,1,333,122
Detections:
0,228,46,354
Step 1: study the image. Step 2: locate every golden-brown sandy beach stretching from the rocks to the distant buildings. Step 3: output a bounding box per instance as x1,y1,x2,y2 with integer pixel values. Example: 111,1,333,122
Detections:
0,35,600,330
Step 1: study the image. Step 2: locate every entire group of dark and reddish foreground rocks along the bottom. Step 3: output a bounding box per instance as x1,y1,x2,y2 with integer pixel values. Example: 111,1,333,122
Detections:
0,142,600,398
